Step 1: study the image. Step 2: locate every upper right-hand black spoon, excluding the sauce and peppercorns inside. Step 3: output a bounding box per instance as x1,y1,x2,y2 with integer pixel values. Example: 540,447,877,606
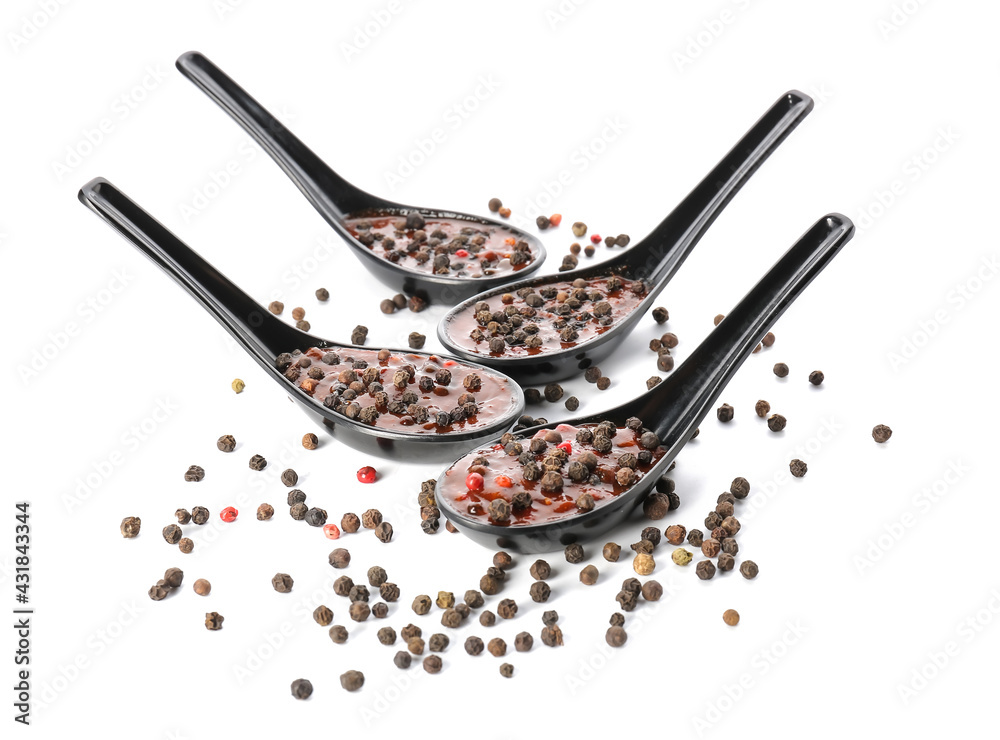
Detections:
438,90,813,383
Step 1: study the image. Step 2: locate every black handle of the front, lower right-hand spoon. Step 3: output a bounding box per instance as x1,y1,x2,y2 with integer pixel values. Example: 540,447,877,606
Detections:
636,213,854,452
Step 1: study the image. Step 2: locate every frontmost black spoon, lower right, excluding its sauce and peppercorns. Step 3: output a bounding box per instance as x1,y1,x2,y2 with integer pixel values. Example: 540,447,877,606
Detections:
436,214,854,552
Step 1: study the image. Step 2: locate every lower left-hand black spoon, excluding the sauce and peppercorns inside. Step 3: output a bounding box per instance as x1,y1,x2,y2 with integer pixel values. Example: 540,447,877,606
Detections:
79,178,524,460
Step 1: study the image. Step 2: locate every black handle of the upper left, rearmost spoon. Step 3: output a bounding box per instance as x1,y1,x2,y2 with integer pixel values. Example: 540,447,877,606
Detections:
177,51,394,220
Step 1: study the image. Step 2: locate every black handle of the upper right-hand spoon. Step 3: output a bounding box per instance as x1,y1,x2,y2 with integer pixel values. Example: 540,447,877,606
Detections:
626,90,813,286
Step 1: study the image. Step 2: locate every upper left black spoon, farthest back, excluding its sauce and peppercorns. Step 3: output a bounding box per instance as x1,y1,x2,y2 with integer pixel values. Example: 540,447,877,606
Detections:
177,51,545,305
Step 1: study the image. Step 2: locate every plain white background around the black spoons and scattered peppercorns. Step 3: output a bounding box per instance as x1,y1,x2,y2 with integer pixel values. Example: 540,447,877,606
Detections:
0,0,1000,738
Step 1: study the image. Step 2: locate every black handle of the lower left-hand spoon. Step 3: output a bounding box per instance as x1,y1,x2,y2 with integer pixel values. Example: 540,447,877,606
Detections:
79,177,306,368
